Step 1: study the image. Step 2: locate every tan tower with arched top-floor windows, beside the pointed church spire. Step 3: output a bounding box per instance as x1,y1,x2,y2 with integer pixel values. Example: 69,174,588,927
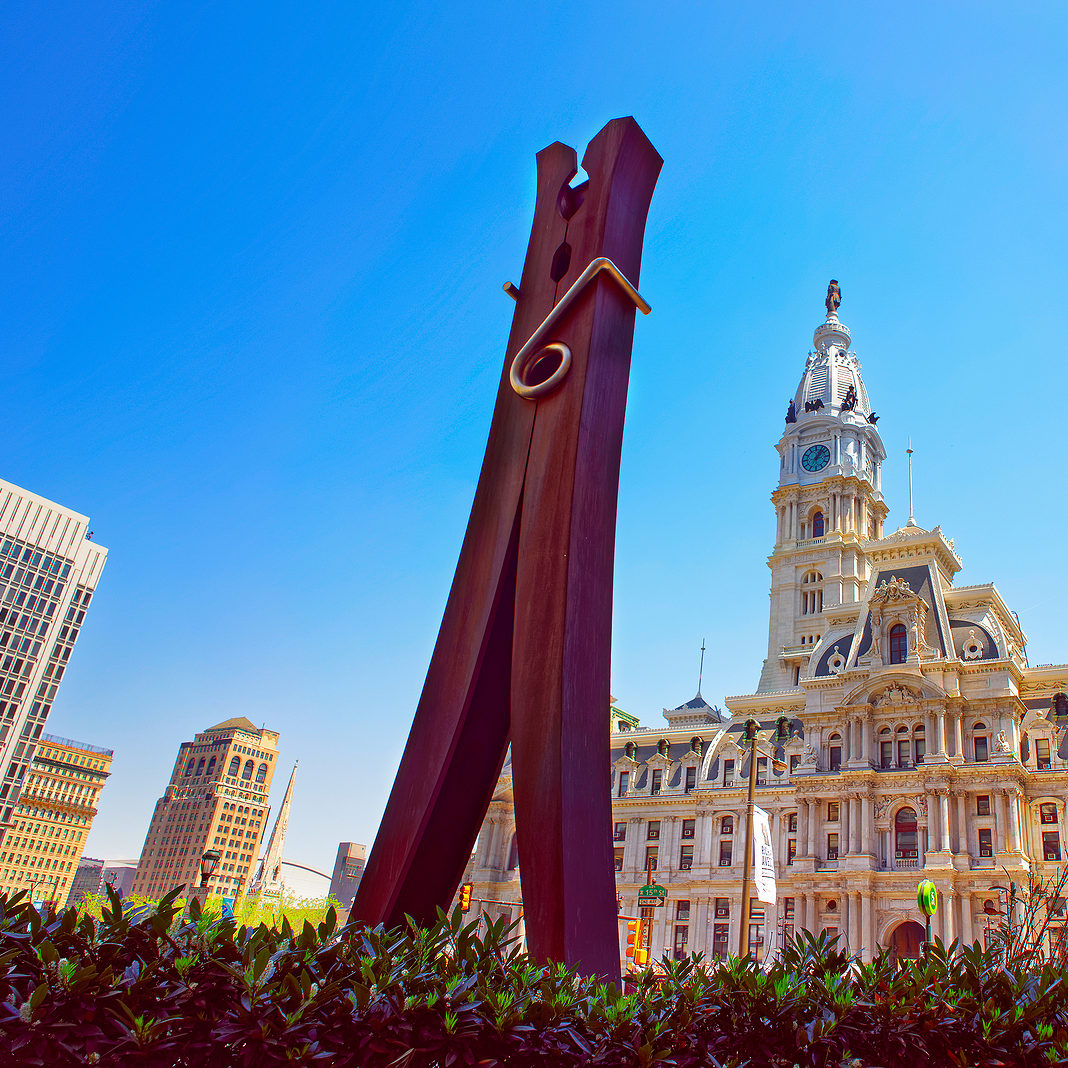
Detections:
130,717,278,898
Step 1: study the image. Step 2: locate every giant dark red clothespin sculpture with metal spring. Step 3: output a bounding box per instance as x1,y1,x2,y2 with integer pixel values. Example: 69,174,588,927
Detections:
352,119,662,980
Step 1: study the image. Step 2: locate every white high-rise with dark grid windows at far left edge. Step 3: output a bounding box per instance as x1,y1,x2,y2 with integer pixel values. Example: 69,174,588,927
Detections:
0,480,108,842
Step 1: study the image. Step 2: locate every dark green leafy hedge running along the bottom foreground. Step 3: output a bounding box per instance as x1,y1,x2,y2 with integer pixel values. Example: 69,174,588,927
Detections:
0,892,1068,1068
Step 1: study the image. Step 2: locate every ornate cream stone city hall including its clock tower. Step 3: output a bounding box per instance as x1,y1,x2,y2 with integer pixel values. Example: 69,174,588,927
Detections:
467,288,1068,959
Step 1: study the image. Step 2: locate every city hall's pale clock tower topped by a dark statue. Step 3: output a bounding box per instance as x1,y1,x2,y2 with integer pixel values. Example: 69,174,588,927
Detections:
757,281,888,693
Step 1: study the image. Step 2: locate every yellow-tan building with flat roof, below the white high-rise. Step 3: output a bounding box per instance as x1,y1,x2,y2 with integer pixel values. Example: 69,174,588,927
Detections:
0,734,114,906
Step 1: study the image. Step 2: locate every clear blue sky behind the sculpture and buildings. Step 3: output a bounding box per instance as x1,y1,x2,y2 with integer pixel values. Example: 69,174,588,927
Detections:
0,0,1068,867
